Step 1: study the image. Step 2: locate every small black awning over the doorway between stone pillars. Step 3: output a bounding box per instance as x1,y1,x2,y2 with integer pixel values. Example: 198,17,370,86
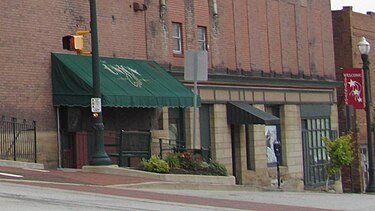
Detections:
227,102,280,125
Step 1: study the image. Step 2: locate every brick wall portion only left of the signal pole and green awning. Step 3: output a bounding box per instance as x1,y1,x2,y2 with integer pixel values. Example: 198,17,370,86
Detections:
0,0,89,130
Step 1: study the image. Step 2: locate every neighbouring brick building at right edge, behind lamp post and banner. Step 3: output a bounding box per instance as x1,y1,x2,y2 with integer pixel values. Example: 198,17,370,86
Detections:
333,7,375,149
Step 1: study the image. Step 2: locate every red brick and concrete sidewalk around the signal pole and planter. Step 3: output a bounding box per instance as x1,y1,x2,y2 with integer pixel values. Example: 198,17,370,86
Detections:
0,160,253,190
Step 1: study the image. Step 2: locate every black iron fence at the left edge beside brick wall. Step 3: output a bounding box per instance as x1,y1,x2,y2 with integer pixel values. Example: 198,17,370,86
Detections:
0,116,36,163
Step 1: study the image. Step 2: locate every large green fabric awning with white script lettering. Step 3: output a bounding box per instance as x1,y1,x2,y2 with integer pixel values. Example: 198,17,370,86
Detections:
52,53,200,108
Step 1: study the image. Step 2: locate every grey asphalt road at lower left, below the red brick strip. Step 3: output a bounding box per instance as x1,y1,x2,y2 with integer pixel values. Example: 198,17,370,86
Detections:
0,183,235,211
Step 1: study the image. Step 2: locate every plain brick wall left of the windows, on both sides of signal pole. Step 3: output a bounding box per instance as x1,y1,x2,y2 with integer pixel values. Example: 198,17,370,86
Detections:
0,0,150,129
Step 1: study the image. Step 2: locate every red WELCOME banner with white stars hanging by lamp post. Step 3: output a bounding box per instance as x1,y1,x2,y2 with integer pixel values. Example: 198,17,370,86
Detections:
343,68,365,109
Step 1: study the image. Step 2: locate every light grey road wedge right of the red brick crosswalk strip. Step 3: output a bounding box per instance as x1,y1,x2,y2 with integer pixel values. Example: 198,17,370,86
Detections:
143,189,375,211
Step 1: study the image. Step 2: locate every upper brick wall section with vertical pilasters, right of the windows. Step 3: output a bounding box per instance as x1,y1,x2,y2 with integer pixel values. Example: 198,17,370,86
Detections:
211,0,335,79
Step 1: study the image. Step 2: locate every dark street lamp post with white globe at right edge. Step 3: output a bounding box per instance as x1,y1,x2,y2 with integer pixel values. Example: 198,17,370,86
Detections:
358,37,375,192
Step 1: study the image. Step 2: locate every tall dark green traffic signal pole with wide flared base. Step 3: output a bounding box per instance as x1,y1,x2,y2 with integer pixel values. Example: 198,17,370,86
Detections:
90,0,112,166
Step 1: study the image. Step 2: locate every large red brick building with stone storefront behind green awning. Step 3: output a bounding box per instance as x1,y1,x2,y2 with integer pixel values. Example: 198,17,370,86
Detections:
0,0,338,189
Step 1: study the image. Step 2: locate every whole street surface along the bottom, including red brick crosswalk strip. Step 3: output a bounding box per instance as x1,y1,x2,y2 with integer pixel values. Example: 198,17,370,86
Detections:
0,167,375,211
